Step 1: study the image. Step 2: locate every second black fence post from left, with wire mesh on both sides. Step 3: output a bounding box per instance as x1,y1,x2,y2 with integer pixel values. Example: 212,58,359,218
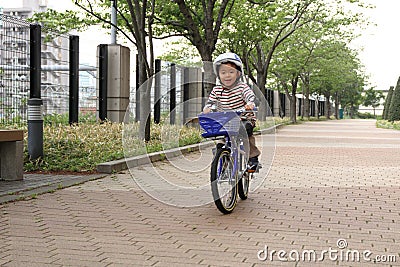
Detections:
69,35,79,124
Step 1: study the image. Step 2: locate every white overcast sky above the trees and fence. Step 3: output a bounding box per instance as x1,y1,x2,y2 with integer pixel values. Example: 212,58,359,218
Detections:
0,0,400,90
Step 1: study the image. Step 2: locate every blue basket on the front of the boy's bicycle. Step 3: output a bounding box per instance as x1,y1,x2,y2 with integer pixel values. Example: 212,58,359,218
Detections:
199,111,240,138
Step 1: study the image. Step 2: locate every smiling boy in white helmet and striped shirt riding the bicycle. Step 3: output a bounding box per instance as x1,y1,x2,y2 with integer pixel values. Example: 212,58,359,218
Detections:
203,53,261,172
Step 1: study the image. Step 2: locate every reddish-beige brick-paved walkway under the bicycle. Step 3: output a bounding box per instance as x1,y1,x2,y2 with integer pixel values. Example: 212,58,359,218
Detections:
0,120,400,266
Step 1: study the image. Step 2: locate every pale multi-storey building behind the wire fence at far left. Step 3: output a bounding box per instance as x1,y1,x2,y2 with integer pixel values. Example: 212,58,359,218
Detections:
0,0,69,113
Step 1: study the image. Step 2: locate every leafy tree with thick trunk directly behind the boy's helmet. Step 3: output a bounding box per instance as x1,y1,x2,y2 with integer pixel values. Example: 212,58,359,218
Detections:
155,0,241,94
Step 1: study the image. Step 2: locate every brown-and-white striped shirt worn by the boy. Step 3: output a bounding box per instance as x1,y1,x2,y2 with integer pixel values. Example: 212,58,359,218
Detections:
204,81,255,120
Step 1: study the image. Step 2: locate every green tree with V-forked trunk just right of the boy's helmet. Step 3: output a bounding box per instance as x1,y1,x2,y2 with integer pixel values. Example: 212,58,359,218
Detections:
220,0,323,114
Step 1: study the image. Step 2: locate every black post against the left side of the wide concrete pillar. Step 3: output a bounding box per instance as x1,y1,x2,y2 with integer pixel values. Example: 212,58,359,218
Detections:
99,44,108,121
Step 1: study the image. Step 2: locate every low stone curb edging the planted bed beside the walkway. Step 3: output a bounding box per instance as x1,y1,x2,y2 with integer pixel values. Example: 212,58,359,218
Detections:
97,124,285,174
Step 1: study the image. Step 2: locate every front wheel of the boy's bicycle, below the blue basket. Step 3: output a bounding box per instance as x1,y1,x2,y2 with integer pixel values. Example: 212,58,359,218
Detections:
211,148,237,214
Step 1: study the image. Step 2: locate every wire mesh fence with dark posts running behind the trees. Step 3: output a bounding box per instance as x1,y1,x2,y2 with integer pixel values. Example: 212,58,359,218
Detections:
0,14,323,130
